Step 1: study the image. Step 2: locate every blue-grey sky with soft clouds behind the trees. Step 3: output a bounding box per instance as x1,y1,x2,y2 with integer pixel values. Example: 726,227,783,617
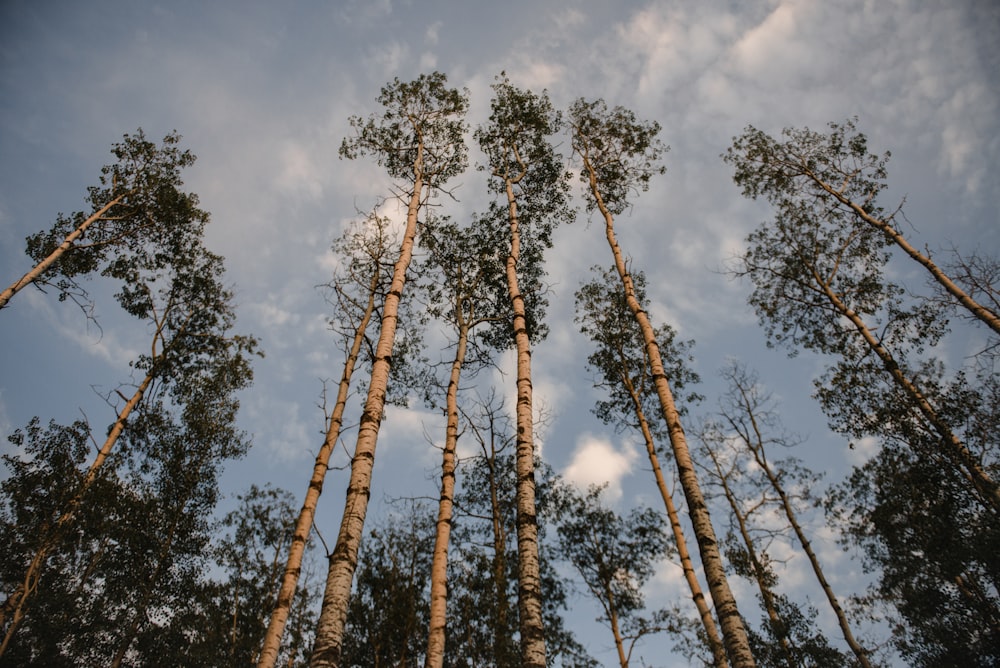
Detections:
0,0,1000,665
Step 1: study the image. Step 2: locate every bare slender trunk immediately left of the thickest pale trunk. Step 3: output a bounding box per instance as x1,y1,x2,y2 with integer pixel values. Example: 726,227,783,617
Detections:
257,266,379,668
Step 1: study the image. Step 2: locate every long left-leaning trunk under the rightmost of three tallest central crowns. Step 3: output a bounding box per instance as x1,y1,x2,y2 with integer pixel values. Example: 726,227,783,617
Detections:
584,163,755,668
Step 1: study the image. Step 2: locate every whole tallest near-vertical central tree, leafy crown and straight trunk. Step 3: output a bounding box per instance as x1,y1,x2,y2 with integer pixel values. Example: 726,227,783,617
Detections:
475,74,573,666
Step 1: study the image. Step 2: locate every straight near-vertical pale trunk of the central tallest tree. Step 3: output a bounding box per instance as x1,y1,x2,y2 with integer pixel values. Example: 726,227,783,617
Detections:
506,177,545,668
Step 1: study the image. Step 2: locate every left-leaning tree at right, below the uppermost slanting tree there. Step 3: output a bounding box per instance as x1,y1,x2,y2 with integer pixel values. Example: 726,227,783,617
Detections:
727,128,1000,513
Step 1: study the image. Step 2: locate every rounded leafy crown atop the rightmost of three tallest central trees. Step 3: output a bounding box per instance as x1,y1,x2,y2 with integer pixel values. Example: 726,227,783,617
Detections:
569,98,669,215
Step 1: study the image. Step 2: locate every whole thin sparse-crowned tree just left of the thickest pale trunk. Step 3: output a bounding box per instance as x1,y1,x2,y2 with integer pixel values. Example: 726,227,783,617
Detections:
257,211,392,668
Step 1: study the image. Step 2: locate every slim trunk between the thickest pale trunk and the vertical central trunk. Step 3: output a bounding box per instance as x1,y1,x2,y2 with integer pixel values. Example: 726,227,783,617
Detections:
424,318,469,668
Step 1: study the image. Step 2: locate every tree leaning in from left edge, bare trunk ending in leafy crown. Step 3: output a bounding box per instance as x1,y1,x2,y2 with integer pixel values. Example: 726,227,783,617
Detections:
0,128,208,316
